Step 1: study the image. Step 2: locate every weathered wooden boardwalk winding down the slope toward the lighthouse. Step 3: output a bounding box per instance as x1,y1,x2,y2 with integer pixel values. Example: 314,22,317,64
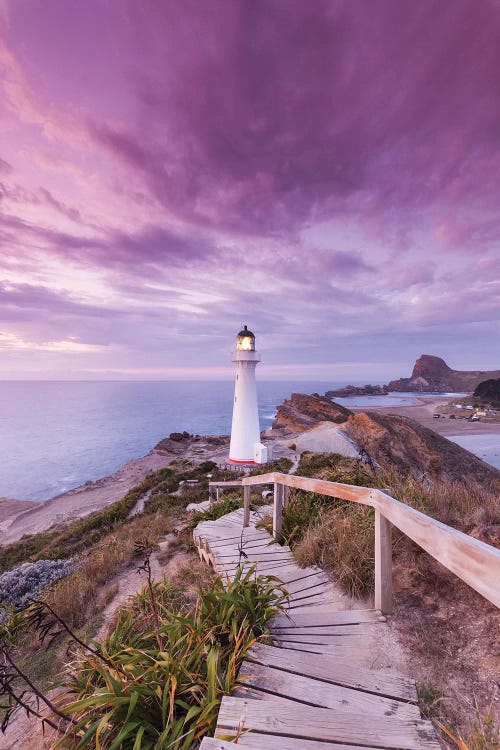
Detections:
194,509,440,750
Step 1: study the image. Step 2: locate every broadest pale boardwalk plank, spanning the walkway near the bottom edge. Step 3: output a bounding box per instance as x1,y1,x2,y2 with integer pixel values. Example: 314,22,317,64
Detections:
216,696,440,750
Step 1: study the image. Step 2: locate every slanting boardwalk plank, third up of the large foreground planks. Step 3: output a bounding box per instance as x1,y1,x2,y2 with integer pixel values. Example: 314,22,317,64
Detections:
248,643,418,702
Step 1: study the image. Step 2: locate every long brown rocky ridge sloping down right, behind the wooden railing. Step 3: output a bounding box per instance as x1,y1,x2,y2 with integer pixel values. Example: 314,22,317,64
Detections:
342,412,500,491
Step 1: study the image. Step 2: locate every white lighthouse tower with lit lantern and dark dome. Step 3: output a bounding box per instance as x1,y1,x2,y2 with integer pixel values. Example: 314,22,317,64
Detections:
229,326,267,464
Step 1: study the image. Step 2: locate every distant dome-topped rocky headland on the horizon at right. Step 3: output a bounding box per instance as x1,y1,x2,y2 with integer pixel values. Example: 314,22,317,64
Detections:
385,354,500,393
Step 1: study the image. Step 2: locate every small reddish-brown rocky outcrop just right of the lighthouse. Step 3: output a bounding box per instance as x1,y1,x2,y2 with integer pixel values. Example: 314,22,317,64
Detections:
272,393,352,433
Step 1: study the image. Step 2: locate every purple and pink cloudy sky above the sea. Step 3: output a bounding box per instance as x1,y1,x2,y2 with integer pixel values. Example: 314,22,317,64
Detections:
0,0,500,382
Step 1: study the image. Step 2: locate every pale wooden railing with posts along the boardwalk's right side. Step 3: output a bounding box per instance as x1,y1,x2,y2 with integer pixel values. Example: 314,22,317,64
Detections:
210,473,500,614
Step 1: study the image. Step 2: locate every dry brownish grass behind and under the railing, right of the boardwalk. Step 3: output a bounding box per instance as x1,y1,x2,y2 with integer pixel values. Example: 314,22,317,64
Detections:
270,452,500,596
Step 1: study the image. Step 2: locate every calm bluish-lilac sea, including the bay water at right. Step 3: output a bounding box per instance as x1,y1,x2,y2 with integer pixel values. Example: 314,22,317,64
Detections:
0,381,500,500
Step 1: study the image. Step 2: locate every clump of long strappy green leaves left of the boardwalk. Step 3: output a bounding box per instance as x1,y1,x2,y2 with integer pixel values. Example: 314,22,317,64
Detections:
55,571,285,750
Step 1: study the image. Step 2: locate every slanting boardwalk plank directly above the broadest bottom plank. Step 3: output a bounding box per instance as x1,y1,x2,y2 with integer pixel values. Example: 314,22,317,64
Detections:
238,661,420,719
